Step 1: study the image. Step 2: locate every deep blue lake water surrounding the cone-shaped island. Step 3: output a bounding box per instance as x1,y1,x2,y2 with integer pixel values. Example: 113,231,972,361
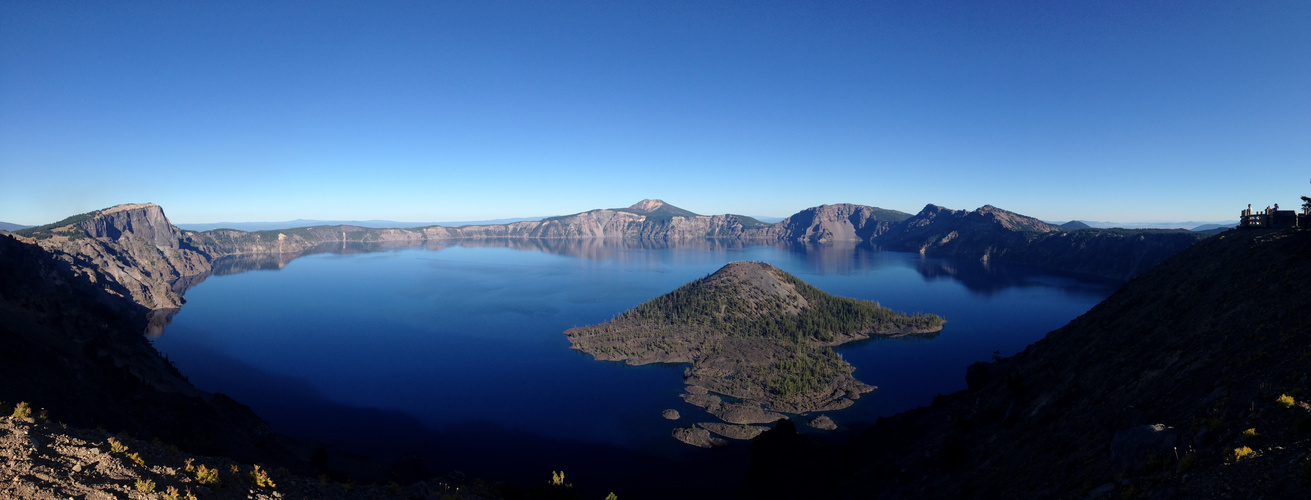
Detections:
155,241,1114,496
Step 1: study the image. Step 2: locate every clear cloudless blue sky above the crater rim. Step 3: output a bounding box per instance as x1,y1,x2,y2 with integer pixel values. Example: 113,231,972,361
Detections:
0,0,1311,224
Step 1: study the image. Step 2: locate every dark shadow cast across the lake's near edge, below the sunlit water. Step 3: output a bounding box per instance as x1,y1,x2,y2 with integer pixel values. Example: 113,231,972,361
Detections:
161,330,749,499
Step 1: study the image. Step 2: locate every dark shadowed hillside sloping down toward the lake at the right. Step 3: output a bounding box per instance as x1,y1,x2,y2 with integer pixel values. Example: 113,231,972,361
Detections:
746,230,1311,499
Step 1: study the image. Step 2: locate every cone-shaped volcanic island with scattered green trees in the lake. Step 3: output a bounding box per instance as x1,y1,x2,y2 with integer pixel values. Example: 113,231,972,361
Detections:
565,262,947,446
